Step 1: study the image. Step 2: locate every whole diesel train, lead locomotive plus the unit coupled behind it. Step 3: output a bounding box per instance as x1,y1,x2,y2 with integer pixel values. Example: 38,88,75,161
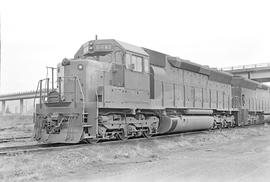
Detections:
34,39,270,143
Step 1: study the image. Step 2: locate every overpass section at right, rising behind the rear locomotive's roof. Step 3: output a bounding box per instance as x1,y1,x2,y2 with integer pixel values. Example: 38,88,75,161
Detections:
221,63,270,82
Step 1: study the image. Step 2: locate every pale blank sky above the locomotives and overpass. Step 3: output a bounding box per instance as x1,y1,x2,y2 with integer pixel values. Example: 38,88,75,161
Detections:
0,0,270,93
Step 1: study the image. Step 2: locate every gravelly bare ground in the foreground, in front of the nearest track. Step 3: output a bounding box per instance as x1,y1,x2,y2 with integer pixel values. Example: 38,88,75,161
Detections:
0,116,270,182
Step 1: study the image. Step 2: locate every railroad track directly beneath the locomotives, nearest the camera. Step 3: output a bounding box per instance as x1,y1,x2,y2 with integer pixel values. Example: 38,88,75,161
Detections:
0,125,266,155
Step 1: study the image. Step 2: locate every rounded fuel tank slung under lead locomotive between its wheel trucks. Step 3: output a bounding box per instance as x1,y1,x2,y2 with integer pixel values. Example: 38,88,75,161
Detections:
158,116,214,134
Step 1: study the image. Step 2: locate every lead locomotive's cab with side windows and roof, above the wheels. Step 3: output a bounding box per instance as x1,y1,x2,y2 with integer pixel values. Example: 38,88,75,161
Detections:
74,40,150,109
